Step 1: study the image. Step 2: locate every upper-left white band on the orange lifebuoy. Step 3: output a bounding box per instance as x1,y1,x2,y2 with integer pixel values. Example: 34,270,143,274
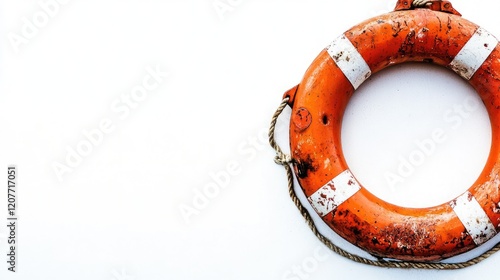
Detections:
327,35,372,89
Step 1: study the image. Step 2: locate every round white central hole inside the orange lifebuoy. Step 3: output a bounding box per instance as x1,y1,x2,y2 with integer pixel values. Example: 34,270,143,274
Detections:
342,63,491,208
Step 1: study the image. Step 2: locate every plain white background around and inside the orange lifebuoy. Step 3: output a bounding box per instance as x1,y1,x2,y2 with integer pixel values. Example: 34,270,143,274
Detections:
0,0,500,280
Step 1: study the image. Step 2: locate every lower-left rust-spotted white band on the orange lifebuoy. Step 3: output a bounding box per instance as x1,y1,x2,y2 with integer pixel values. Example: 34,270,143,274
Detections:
308,170,361,217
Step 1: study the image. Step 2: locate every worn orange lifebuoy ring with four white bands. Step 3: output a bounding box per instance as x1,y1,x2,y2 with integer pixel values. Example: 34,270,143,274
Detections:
284,0,500,261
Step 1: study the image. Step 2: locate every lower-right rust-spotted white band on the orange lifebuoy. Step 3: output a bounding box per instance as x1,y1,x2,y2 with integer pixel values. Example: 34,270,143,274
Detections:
450,192,497,245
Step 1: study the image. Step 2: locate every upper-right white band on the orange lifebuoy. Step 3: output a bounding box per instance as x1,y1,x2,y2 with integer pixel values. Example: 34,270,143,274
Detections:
450,27,498,80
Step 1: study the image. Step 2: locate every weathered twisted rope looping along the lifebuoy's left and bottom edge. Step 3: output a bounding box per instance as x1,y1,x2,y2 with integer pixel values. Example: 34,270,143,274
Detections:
269,98,500,270
